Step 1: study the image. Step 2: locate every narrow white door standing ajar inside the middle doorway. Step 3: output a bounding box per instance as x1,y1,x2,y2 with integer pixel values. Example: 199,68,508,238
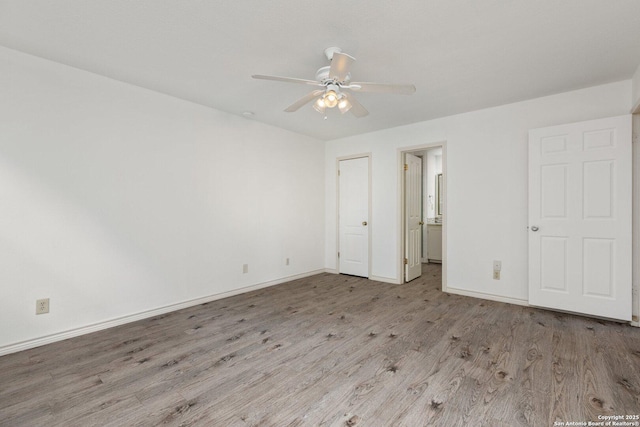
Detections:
404,153,422,282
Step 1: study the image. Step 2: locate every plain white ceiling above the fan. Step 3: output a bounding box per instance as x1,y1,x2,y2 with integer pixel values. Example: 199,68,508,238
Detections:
0,0,640,140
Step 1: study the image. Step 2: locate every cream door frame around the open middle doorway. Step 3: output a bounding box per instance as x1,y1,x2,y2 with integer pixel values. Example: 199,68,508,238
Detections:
396,141,449,292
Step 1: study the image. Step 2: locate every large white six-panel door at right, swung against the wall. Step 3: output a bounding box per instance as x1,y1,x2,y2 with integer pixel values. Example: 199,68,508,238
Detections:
529,116,632,320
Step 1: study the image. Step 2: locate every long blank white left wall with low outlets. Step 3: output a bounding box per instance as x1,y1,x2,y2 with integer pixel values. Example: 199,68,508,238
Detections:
0,48,325,353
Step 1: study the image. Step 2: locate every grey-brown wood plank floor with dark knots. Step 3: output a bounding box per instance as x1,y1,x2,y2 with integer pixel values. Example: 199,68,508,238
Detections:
0,265,640,427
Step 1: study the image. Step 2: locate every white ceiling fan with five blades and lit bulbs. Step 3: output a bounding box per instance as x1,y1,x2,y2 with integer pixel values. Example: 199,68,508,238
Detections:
251,47,416,118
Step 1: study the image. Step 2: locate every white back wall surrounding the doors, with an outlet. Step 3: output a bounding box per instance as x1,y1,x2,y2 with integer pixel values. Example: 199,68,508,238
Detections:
325,80,631,302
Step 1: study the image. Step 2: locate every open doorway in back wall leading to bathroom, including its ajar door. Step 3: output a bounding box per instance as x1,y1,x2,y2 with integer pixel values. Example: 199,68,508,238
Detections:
398,142,446,286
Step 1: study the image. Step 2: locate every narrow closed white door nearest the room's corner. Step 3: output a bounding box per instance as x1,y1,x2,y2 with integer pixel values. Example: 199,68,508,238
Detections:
338,157,369,277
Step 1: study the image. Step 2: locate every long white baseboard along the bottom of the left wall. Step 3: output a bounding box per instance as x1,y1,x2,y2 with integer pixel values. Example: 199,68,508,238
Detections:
0,269,325,356
